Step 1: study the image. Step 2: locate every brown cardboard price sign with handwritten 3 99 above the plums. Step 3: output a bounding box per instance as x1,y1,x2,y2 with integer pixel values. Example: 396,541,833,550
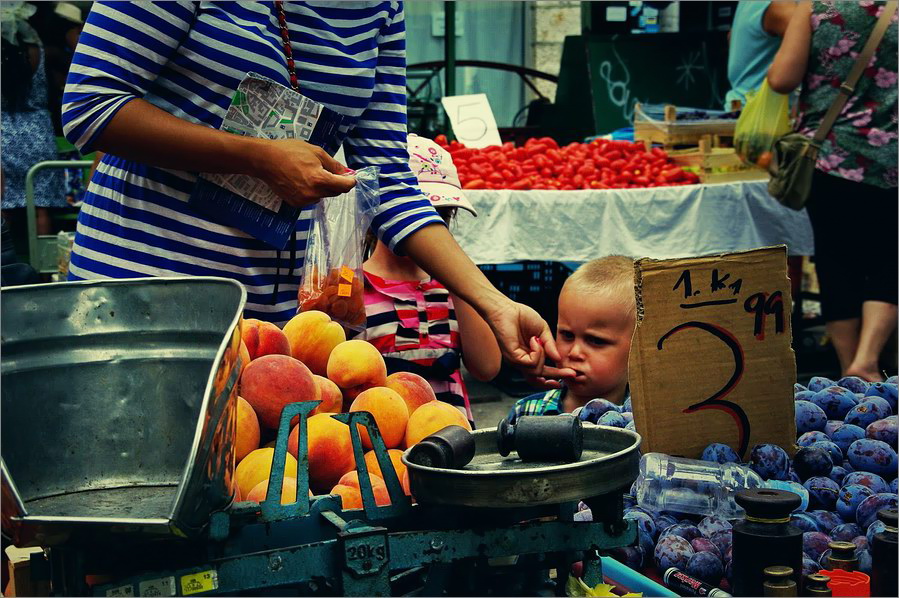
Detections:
629,246,796,460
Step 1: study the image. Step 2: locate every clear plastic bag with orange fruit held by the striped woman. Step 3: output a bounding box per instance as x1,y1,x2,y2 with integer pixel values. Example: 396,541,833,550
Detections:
297,166,380,332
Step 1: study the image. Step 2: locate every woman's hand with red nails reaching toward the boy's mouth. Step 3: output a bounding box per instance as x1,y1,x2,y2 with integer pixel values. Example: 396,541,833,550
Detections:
486,299,575,388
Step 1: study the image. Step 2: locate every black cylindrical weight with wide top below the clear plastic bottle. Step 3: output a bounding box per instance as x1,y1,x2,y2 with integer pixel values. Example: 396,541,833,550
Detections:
732,488,802,596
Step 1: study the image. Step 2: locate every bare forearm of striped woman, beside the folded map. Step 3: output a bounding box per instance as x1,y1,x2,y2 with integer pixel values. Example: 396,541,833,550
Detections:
94,99,267,176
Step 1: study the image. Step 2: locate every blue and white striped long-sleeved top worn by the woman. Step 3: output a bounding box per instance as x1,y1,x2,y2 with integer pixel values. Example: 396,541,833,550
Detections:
62,2,443,323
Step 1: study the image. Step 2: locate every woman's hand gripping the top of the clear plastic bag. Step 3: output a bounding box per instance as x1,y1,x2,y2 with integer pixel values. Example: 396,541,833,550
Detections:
255,139,356,207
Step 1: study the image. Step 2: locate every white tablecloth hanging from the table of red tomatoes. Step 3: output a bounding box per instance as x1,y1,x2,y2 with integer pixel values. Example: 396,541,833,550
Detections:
453,181,813,264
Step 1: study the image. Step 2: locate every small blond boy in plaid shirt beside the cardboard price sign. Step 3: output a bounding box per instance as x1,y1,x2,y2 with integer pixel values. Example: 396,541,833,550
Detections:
509,255,637,421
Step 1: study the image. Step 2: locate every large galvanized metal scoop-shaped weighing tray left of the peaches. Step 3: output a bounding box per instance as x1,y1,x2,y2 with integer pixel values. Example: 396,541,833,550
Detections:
0,277,246,546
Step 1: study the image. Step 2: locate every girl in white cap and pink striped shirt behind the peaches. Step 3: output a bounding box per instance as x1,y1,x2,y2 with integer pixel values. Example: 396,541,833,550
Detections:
357,135,501,424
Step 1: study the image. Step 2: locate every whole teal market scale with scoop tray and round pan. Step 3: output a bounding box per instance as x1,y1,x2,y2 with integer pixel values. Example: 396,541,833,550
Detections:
2,278,640,596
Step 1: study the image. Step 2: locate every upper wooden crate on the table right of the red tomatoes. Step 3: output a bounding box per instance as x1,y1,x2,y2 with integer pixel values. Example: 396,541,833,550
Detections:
634,104,737,150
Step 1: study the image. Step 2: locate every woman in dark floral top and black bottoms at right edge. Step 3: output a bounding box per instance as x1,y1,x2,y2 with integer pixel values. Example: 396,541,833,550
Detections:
768,0,899,381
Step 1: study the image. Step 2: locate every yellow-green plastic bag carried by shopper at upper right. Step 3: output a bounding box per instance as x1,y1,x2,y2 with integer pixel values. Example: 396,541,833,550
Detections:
734,79,793,170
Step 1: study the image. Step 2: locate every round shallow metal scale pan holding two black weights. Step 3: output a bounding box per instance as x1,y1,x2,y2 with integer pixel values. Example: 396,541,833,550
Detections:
403,423,641,508
